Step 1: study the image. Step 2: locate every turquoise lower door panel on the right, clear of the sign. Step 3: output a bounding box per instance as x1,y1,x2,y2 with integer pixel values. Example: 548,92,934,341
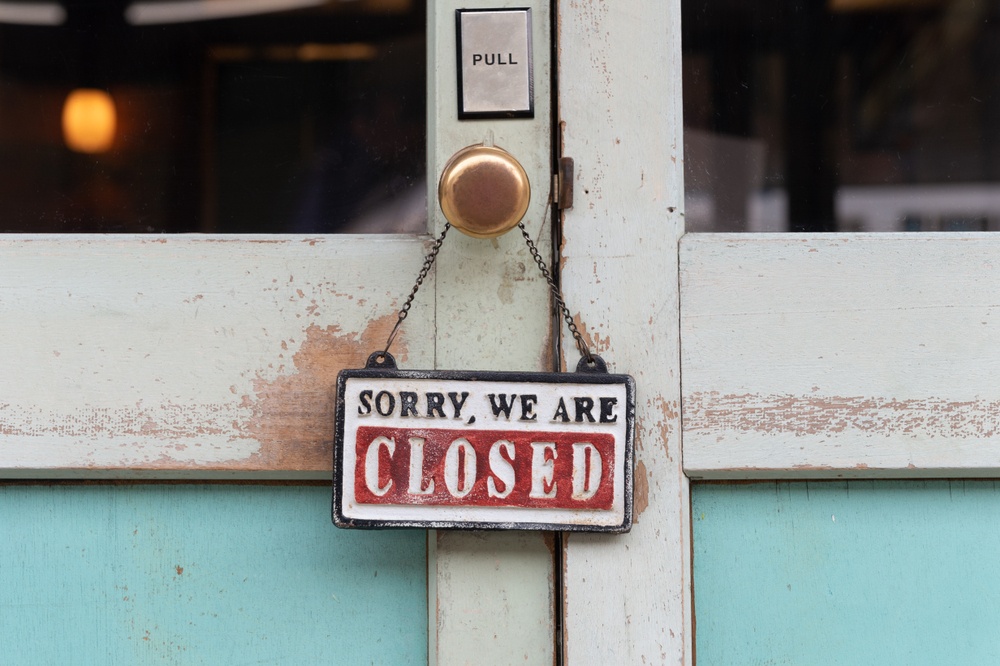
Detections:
691,481,1000,666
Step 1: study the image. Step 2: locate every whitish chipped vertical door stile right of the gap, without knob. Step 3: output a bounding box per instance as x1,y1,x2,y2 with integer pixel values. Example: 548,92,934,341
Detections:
559,0,693,664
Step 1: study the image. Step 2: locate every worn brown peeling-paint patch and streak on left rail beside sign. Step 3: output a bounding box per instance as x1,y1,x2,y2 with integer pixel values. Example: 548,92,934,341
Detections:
0,314,406,471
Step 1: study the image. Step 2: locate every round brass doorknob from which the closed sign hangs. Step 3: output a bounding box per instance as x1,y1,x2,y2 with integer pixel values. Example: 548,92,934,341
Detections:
438,144,531,238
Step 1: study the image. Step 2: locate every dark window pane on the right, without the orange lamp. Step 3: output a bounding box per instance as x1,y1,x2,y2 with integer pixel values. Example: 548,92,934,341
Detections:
682,0,1000,231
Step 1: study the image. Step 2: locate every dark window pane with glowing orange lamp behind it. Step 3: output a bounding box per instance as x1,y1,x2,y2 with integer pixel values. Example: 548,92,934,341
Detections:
0,0,426,233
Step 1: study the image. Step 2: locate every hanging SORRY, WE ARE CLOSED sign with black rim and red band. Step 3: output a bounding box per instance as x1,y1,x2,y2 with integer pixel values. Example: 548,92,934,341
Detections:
333,355,635,532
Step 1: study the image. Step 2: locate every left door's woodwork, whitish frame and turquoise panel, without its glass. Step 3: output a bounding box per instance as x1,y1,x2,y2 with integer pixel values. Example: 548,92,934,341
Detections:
0,2,556,664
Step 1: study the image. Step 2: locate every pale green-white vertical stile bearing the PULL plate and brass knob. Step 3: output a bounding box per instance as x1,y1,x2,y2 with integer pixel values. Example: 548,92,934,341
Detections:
428,0,555,666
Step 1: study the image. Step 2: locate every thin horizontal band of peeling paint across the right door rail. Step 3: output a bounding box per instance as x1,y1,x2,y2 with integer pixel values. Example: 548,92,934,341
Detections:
684,391,1000,439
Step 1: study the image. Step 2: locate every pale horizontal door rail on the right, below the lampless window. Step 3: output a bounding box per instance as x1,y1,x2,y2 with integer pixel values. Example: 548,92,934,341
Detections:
681,234,1000,478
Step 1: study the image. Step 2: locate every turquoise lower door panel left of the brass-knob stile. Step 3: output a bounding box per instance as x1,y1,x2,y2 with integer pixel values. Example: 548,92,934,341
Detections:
0,485,427,666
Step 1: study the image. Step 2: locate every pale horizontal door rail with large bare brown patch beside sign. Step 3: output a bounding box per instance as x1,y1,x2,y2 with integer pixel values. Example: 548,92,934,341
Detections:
0,236,434,478
